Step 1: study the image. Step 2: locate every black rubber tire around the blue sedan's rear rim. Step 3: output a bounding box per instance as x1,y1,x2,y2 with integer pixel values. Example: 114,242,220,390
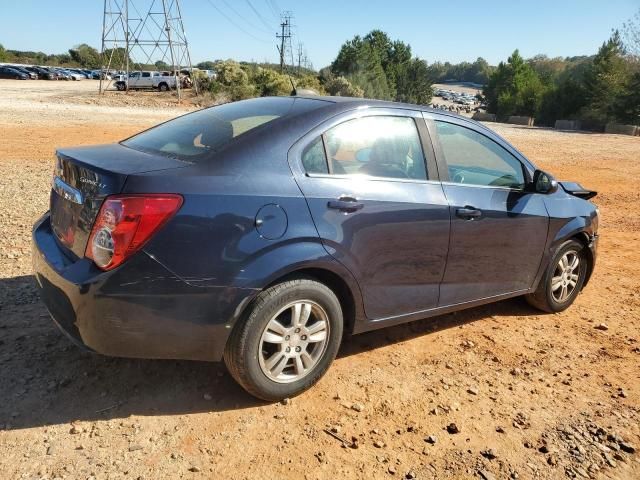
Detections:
224,278,343,402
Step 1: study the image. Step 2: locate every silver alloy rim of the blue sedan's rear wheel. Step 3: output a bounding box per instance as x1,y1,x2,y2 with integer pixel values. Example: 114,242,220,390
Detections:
258,300,329,383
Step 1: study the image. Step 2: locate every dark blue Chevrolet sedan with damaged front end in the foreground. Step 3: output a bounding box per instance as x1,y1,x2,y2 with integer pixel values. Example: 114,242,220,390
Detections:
33,97,598,401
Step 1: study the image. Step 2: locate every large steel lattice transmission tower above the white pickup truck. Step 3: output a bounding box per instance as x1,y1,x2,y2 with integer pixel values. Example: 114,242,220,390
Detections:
100,0,197,99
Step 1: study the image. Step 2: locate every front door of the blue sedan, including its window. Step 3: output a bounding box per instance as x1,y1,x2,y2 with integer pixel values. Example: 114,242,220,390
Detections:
428,120,549,306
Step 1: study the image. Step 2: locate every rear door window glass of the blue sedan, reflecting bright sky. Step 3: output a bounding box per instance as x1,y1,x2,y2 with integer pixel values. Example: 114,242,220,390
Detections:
302,116,427,180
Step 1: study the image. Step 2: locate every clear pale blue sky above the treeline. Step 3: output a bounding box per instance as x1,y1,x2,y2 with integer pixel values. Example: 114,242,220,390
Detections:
0,0,640,68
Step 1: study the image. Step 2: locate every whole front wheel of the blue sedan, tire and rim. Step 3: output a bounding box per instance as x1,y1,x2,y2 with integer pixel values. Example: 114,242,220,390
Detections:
526,240,589,313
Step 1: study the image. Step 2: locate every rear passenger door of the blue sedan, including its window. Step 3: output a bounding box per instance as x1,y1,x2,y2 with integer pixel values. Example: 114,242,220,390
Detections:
290,109,450,320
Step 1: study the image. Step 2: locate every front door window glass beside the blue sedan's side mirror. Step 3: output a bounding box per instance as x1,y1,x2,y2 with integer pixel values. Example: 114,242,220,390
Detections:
435,121,525,189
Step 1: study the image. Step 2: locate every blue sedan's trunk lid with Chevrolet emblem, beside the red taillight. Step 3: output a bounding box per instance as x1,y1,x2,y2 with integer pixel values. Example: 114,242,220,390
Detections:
50,144,189,258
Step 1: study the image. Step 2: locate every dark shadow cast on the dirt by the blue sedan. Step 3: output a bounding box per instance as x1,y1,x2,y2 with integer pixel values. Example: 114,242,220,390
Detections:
0,275,531,430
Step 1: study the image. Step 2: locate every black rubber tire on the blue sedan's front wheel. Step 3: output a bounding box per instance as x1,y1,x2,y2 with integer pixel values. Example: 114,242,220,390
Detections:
525,240,589,313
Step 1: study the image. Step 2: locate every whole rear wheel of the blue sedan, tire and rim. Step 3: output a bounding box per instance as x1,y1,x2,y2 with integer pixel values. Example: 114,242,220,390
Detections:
224,278,343,401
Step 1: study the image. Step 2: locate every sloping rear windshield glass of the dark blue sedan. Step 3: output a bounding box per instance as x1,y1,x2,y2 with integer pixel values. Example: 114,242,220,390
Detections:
122,97,327,162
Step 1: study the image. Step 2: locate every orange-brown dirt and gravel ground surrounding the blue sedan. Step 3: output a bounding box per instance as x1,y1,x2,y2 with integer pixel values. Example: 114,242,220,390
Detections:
0,81,640,480
